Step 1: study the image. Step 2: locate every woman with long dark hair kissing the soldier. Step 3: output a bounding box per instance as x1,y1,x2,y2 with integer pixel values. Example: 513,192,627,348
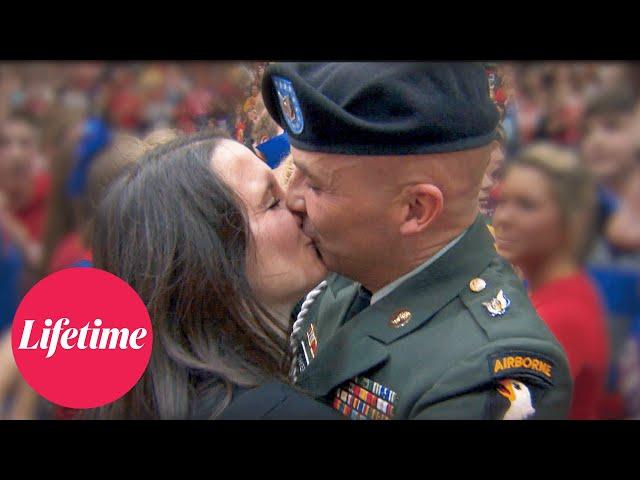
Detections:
87,132,337,419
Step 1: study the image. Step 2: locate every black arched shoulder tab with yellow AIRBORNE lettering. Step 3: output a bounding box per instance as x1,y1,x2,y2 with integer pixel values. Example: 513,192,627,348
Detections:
488,350,555,385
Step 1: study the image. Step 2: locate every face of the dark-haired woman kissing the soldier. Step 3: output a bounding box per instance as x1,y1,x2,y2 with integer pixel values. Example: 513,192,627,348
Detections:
212,140,327,306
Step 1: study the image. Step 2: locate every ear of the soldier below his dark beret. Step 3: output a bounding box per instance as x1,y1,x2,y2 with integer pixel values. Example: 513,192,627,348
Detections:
400,183,444,235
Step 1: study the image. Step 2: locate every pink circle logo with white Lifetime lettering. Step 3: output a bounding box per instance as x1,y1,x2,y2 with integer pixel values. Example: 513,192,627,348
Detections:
11,268,153,409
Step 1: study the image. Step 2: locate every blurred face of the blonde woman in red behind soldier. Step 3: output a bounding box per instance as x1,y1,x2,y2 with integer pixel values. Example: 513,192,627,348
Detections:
493,166,564,266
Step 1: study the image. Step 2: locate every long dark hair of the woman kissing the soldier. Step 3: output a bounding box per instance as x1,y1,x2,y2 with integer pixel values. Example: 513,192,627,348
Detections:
88,131,287,419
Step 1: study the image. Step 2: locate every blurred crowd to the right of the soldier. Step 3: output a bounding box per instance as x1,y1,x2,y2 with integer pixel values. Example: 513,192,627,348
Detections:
480,62,640,418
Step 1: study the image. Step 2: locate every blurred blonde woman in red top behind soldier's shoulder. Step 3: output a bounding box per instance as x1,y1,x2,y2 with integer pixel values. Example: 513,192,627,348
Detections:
493,144,609,419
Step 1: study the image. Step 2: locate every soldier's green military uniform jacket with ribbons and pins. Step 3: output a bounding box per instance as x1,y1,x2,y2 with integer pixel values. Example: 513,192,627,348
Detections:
290,217,572,419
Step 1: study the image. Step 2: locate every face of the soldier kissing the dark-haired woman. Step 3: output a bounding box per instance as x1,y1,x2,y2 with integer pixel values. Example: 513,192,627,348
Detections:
287,148,398,280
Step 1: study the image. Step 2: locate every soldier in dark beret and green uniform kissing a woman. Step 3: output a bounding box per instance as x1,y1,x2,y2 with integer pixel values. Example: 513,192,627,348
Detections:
262,63,572,419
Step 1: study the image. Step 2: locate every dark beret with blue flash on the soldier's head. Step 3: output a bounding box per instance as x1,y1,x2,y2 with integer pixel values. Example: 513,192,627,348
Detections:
262,62,499,155
